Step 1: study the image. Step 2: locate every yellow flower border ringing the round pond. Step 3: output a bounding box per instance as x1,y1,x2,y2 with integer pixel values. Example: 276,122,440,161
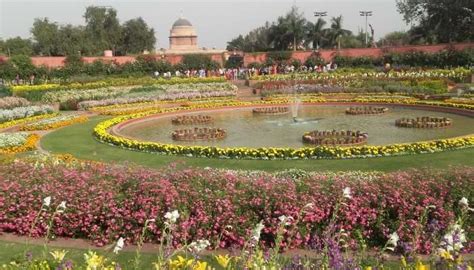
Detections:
94,99,474,159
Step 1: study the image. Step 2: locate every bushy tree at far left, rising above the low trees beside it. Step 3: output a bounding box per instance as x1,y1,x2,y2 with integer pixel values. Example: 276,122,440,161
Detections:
31,18,59,56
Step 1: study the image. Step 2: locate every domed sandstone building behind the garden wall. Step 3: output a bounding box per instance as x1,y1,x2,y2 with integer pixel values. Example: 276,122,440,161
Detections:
170,17,199,51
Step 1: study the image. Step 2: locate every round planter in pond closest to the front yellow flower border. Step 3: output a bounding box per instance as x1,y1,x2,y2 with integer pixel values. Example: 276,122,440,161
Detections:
303,130,368,146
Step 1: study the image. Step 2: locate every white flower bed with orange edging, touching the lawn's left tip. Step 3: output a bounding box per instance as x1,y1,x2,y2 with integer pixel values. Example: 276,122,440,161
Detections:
0,132,39,154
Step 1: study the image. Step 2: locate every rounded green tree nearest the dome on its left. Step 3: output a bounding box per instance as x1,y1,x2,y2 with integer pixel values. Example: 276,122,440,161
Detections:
122,17,156,54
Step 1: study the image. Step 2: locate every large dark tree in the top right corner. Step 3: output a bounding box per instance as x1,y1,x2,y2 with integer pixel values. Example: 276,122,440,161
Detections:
397,0,474,42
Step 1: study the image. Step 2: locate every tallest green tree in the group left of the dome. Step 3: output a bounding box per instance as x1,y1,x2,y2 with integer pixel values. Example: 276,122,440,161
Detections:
84,6,121,55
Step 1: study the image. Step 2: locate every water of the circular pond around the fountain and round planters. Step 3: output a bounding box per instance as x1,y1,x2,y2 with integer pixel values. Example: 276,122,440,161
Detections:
115,105,474,148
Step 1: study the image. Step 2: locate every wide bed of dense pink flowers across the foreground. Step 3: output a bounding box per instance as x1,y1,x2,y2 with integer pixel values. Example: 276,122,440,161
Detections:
0,157,474,252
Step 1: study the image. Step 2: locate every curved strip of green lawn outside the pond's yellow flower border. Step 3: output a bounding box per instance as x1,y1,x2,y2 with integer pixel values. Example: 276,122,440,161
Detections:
41,116,474,171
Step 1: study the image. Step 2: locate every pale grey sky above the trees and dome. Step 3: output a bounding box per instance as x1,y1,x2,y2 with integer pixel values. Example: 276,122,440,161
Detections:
0,0,409,49
